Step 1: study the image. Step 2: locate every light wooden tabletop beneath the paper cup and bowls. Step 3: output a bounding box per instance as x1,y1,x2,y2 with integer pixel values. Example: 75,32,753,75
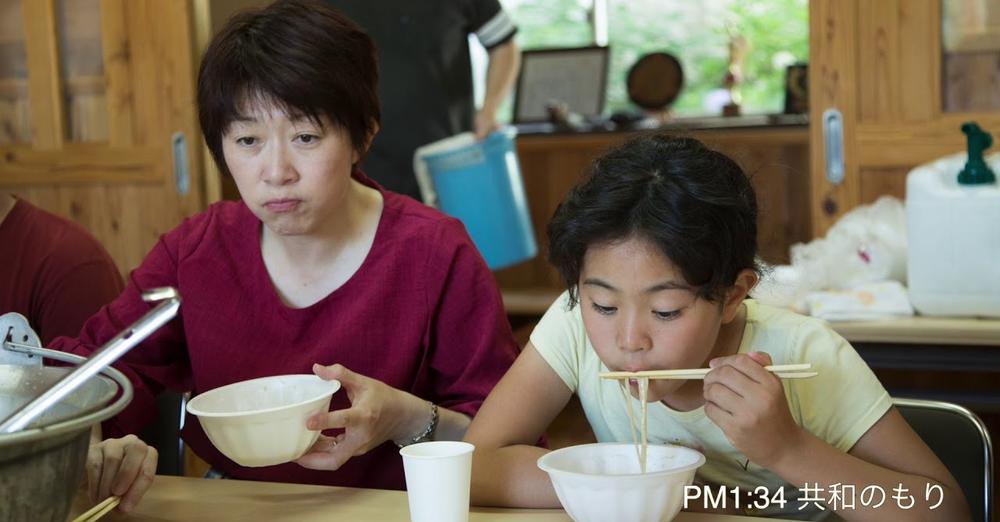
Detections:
72,476,780,522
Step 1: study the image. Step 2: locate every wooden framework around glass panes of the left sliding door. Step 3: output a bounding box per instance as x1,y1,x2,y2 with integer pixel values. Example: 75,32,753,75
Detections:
0,0,204,202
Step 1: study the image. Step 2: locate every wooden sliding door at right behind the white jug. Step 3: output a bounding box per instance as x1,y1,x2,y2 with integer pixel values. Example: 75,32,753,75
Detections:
809,0,1000,236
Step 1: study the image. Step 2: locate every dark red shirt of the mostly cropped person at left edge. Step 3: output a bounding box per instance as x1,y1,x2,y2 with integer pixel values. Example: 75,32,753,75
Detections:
0,199,124,346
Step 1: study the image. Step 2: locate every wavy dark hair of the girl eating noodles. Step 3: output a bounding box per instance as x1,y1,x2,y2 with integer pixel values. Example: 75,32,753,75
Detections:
548,134,758,305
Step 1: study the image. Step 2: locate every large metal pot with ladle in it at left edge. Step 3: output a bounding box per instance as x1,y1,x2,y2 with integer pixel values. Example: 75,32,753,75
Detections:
0,287,181,522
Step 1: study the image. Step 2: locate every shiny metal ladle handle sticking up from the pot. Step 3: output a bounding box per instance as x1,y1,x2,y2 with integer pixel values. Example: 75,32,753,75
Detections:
0,287,181,433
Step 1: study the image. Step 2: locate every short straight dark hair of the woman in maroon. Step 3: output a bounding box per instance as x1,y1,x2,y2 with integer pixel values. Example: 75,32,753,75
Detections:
198,0,381,174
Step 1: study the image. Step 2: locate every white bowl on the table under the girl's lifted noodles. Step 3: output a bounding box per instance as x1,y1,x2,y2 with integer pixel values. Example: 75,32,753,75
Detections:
538,443,705,522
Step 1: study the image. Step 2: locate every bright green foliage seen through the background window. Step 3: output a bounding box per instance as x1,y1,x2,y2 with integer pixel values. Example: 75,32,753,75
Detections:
502,0,809,115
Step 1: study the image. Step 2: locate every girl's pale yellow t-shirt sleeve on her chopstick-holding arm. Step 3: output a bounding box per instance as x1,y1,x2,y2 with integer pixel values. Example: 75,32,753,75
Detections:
792,321,892,453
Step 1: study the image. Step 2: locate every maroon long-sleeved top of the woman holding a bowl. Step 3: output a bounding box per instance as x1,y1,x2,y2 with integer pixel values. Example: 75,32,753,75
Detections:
48,175,517,489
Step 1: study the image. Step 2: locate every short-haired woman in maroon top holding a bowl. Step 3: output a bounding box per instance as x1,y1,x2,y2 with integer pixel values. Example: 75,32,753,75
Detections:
57,0,516,511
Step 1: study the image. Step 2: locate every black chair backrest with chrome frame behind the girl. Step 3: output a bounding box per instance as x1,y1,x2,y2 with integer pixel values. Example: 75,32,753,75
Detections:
893,398,993,522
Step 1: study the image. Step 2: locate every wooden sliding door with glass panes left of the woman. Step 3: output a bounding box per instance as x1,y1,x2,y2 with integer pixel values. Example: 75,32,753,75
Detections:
0,0,205,272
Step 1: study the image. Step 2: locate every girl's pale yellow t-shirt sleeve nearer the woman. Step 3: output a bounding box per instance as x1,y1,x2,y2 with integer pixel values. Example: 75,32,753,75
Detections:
530,292,588,393
